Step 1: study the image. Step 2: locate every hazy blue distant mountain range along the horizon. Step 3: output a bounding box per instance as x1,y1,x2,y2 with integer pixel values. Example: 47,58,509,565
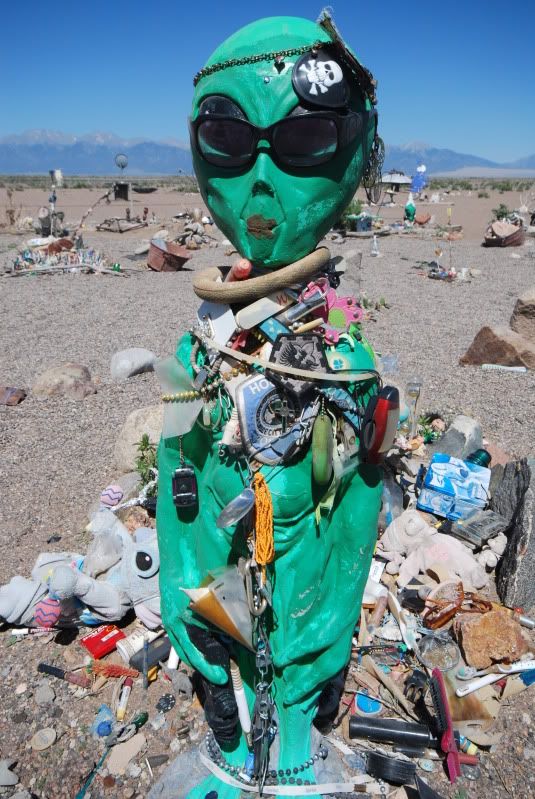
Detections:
0,130,535,177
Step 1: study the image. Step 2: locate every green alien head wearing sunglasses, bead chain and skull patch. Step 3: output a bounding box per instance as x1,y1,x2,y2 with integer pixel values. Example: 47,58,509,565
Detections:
190,17,377,267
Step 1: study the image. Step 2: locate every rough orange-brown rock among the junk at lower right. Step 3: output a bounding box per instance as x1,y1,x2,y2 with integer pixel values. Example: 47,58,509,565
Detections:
454,610,529,669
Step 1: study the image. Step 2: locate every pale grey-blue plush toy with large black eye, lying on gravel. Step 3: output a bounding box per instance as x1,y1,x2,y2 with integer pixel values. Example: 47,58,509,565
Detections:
0,508,161,629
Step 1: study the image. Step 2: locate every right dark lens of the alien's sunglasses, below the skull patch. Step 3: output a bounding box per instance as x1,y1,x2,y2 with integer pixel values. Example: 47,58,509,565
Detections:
273,115,338,167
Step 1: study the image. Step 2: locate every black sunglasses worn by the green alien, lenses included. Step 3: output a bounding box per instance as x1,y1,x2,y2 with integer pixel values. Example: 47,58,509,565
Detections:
189,111,376,169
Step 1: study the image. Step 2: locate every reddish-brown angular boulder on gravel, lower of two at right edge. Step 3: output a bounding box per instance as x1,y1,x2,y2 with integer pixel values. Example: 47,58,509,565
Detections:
459,325,535,369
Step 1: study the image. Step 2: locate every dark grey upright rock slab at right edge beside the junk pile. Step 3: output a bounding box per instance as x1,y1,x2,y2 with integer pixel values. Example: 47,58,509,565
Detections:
491,458,535,612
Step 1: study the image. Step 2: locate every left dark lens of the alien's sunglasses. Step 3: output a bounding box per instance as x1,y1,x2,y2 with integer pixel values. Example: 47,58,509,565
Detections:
197,119,254,167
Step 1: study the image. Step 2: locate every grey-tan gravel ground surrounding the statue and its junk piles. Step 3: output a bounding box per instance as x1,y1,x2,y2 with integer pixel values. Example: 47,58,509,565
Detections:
0,220,535,799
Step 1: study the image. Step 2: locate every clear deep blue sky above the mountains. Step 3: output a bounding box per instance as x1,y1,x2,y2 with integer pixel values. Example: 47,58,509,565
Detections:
0,0,535,161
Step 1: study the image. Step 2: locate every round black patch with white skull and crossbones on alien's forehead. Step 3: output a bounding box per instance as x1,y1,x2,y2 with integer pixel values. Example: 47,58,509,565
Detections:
292,50,349,108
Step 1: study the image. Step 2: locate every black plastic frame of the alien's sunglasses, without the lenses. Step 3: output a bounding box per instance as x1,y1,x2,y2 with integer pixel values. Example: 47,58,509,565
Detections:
188,109,377,170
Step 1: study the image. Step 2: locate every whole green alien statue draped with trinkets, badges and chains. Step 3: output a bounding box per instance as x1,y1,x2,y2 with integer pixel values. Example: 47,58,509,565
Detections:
153,12,392,799
